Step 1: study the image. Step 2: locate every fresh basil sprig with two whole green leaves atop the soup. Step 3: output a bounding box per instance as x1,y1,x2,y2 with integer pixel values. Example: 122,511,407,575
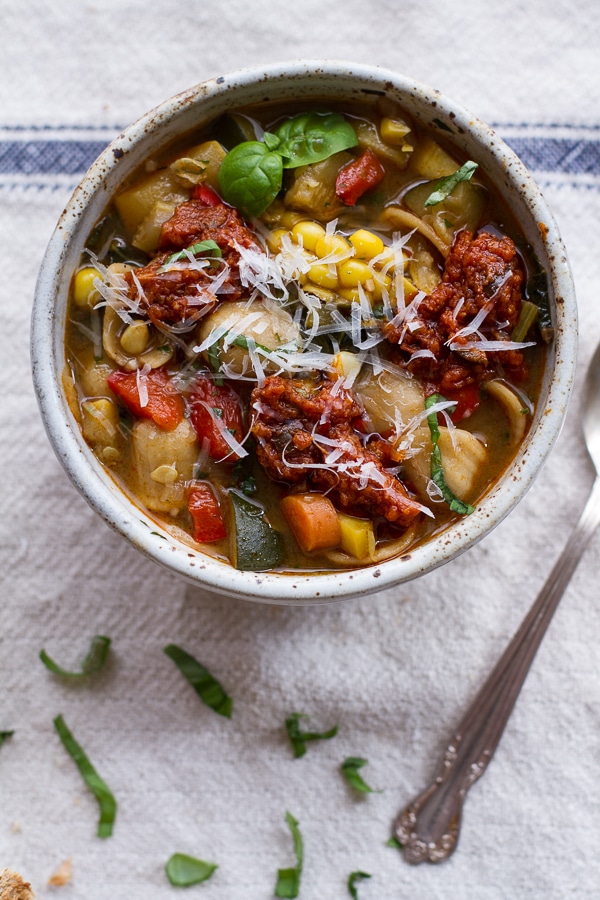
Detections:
219,112,358,216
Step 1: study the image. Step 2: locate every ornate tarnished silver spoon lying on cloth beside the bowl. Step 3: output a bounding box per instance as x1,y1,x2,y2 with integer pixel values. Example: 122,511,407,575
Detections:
393,346,600,864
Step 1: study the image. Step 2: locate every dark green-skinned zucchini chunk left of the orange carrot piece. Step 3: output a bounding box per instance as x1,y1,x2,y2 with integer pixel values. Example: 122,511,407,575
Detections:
228,488,283,572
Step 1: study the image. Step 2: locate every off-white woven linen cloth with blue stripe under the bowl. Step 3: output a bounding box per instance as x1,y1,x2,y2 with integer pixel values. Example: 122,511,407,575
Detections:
0,0,600,900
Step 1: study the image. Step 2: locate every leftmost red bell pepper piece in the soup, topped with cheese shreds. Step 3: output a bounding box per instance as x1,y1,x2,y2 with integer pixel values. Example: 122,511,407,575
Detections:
107,369,185,431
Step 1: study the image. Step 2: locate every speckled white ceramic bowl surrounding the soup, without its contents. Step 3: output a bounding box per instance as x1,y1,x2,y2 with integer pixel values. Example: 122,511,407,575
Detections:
31,60,577,604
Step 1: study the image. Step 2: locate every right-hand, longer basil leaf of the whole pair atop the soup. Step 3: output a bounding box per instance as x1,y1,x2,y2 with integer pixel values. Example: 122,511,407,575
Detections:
275,112,358,169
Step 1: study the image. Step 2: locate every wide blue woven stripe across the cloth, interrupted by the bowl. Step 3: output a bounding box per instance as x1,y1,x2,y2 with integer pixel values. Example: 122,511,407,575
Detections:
0,131,600,175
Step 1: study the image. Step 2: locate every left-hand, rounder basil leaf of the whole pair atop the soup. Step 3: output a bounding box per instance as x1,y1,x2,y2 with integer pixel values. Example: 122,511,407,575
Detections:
219,141,283,216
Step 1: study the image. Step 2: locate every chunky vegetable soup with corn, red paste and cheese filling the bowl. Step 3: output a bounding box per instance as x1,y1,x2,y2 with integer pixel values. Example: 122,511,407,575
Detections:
65,103,552,571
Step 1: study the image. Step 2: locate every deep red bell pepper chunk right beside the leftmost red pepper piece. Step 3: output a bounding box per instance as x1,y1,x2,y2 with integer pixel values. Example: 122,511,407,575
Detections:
189,375,244,463
